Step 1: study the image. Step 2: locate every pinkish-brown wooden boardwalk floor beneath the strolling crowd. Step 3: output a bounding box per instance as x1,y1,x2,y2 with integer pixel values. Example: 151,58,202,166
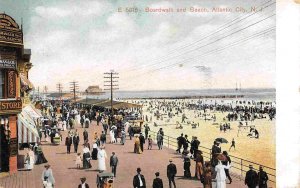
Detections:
0,122,246,188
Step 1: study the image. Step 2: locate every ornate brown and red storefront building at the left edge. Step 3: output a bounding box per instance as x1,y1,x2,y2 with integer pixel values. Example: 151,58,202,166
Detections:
0,13,32,173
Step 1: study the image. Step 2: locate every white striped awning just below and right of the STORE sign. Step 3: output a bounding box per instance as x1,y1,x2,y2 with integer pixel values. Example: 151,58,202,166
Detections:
18,111,39,143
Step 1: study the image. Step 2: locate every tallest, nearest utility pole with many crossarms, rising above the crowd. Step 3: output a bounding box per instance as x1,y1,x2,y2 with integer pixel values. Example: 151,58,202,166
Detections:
104,70,119,123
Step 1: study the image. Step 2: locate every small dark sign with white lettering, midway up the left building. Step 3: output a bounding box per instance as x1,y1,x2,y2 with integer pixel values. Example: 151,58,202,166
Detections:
0,51,17,69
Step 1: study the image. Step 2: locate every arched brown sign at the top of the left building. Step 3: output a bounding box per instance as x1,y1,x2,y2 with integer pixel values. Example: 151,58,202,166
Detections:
0,14,23,45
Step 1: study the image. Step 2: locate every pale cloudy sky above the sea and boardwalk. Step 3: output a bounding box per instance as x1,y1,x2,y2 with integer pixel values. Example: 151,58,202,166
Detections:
0,0,276,91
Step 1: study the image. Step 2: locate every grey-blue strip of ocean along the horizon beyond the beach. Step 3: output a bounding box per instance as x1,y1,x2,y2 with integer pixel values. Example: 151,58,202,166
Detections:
92,89,276,102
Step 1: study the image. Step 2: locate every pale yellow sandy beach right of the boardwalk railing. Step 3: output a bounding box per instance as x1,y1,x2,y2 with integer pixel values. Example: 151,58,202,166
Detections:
127,100,276,173
